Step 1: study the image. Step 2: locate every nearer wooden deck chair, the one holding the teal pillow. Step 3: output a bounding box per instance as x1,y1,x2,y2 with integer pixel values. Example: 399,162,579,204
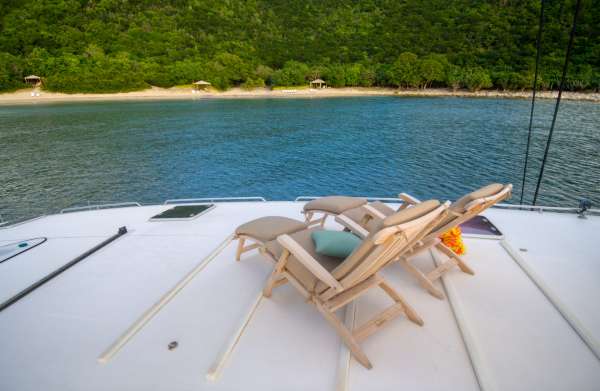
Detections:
262,200,449,369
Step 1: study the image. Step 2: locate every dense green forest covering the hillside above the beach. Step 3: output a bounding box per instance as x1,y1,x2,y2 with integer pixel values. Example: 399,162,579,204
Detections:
0,0,600,92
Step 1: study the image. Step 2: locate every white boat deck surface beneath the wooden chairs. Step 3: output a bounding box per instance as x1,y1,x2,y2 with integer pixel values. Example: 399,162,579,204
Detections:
0,202,600,390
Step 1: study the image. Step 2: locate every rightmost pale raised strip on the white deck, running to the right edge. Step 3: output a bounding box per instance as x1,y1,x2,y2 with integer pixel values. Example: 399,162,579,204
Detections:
500,240,600,360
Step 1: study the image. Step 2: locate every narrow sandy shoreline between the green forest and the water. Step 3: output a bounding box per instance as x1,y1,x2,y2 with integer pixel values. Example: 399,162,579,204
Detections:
0,87,600,106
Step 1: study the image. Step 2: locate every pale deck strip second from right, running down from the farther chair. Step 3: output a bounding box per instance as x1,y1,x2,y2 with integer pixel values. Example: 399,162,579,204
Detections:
429,249,495,391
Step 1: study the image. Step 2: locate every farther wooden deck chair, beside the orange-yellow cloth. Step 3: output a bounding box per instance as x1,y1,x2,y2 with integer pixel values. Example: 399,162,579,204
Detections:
336,183,512,299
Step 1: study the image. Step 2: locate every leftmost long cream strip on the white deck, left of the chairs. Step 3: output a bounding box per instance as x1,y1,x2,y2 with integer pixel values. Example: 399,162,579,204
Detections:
98,234,233,364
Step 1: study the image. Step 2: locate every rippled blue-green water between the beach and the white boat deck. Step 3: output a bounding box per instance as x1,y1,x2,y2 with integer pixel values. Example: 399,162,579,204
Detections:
0,97,600,222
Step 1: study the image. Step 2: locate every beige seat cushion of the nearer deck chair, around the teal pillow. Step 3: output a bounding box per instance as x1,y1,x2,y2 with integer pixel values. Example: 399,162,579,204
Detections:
265,227,343,292
